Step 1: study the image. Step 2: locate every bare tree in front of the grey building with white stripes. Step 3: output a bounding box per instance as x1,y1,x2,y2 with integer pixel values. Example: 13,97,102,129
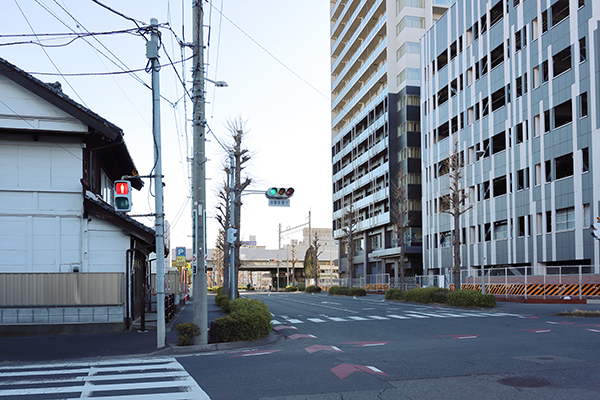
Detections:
440,139,473,289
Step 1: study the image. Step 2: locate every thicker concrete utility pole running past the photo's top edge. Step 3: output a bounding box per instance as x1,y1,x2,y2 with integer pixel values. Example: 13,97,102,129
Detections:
192,0,208,345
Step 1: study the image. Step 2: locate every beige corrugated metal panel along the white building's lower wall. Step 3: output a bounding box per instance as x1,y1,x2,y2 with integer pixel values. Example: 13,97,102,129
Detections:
0,273,124,307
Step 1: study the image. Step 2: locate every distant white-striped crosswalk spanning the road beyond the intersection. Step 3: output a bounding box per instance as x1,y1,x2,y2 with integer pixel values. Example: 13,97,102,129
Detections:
271,311,519,325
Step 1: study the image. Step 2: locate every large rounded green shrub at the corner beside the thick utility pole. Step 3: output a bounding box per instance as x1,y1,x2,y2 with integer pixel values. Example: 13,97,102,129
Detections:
215,298,272,342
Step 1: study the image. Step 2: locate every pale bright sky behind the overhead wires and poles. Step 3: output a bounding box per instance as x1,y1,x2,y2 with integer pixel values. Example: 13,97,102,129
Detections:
0,0,332,249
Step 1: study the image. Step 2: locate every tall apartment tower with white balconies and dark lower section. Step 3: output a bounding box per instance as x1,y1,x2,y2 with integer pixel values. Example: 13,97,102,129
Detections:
331,0,451,277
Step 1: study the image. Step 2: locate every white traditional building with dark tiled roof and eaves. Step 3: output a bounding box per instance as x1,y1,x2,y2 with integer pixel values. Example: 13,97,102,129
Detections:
0,59,154,334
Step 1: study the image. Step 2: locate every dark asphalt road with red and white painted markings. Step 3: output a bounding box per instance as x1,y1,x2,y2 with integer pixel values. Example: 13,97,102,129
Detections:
0,293,600,400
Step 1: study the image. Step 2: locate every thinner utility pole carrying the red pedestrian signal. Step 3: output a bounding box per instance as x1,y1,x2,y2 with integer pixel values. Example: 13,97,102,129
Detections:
146,18,166,349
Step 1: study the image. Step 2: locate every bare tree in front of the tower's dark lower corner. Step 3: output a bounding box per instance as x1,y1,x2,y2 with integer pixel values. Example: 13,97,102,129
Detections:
390,168,415,291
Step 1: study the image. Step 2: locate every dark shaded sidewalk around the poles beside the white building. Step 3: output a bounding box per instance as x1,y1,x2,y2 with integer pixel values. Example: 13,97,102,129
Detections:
0,294,278,362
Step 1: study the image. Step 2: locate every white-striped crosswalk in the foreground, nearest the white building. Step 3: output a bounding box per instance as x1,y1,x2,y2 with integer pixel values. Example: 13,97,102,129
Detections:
0,357,210,400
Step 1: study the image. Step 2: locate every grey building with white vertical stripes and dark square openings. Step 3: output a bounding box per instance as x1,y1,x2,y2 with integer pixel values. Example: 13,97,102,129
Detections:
421,0,600,276
